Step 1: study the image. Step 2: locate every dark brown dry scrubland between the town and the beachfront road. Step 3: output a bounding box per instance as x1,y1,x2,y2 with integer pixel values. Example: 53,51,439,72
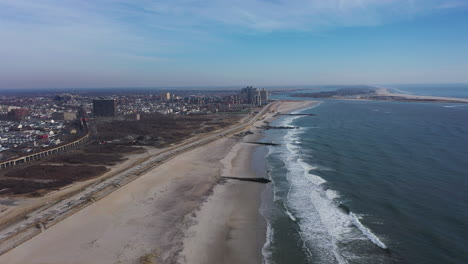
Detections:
0,114,243,195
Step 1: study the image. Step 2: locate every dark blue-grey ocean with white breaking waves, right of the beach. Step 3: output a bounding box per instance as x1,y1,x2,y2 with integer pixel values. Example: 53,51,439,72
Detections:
261,85,468,264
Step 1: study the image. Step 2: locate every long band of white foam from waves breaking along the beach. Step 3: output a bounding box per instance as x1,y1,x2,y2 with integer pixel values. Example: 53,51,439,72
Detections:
270,114,386,263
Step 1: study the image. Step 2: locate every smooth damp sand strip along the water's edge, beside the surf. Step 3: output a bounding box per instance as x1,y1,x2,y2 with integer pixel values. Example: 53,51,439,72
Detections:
179,100,318,264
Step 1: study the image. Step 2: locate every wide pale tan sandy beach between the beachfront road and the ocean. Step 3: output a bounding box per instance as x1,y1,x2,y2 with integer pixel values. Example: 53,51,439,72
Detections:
0,101,313,264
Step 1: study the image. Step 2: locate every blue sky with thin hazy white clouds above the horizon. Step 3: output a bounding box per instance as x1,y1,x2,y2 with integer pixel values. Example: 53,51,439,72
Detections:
0,0,468,89
